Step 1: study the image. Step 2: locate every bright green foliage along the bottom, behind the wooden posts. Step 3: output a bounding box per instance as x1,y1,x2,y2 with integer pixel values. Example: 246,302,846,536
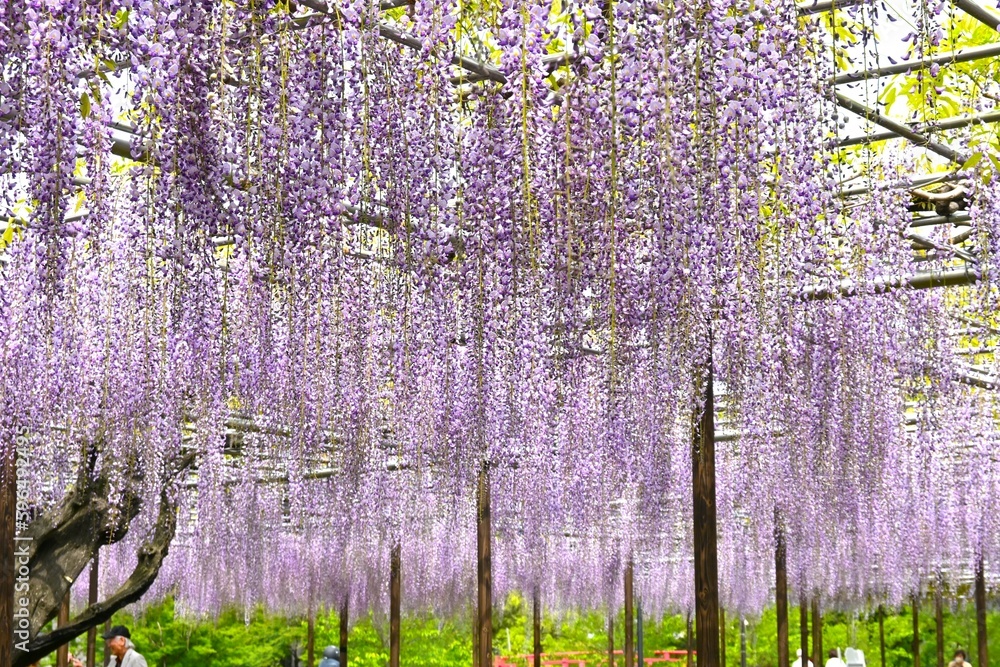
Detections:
42,595,1000,667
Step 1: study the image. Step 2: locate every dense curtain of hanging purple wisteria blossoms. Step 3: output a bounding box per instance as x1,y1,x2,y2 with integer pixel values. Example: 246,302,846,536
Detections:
0,0,1000,632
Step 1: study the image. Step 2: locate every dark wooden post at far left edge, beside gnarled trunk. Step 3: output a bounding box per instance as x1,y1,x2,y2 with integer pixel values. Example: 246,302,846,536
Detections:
0,442,16,665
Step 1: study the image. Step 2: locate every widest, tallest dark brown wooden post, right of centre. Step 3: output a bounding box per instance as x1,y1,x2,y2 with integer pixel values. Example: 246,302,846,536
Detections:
691,366,719,667
